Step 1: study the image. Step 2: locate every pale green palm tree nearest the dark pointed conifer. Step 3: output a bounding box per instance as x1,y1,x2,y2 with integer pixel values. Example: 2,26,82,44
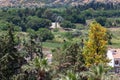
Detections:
22,56,50,80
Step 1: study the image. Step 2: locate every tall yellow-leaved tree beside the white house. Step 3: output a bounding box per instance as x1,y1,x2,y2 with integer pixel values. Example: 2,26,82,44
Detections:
84,22,108,67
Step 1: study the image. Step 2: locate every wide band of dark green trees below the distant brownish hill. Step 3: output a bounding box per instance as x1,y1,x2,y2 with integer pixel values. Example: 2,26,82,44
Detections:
0,5,120,31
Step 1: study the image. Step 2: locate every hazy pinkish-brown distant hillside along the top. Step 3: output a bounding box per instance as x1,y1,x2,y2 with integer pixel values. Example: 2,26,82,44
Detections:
0,0,120,7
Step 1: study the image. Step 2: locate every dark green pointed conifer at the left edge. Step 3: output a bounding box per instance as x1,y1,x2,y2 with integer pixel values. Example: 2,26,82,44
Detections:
0,26,23,80
